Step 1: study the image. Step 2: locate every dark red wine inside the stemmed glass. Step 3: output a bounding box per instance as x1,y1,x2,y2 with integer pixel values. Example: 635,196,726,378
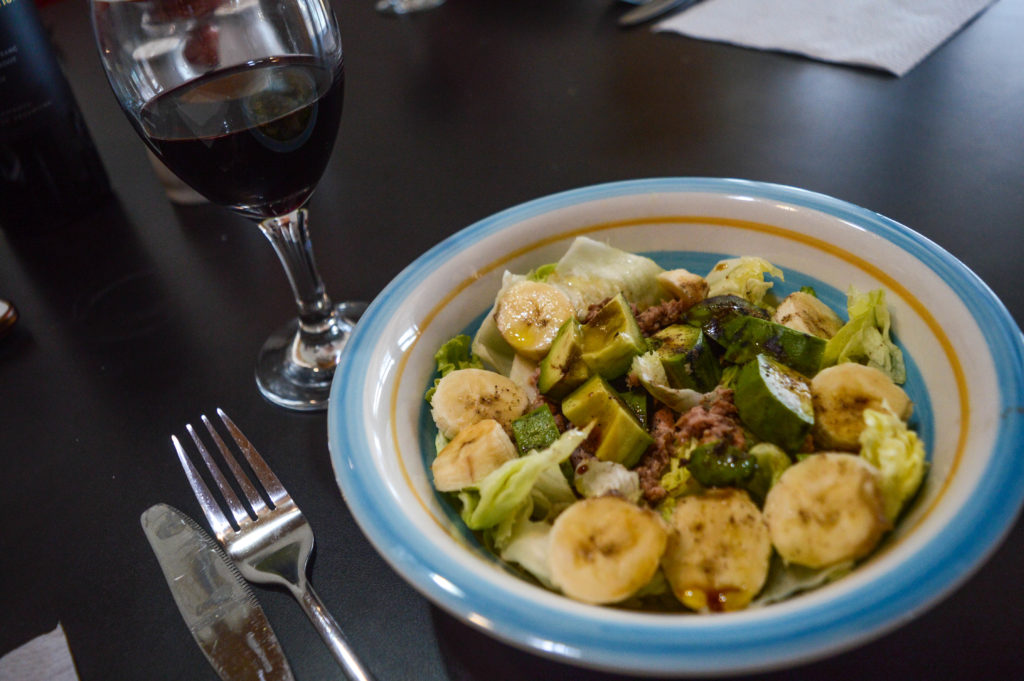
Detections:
139,57,344,218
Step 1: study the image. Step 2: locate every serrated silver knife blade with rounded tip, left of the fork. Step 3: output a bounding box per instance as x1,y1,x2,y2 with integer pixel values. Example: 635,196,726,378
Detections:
140,504,294,681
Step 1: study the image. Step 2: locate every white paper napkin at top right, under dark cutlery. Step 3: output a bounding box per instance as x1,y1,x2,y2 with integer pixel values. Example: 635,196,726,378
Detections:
653,0,993,76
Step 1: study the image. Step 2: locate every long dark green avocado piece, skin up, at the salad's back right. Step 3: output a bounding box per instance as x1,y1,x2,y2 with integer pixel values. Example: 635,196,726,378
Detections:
721,316,826,376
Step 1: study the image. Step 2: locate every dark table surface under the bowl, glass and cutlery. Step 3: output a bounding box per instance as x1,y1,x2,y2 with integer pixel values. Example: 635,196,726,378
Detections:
0,0,1024,681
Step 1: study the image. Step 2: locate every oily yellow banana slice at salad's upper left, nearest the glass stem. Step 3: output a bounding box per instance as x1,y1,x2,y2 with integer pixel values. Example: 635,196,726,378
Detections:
495,282,575,360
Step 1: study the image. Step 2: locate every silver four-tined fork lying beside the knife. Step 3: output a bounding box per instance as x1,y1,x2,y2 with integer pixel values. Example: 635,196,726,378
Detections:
171,409,373,681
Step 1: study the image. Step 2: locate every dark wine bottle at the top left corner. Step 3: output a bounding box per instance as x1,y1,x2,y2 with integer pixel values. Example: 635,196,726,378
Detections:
0,0,111,233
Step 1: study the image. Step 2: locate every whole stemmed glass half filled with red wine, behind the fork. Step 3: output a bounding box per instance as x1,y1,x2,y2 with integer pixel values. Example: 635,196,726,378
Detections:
91,0,366,411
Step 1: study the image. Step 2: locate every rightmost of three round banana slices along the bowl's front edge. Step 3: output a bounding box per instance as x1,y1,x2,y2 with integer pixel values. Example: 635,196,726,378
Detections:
764,452,890,568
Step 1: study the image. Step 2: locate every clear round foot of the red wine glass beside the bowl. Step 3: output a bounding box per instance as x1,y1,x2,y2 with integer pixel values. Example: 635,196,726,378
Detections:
256,301,367,412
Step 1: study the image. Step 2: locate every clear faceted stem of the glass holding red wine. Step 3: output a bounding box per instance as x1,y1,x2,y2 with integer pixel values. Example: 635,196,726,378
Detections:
259,208,334,334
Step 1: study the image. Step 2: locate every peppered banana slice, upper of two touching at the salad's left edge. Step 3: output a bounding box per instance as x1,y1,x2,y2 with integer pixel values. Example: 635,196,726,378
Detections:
430,369,527,439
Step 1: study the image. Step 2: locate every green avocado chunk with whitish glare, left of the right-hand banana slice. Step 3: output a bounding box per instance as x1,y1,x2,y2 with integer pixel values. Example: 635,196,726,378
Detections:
733,354,814,454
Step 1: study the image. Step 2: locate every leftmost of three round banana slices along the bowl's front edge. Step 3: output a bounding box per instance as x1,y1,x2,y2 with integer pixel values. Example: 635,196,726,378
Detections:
548,496,668,604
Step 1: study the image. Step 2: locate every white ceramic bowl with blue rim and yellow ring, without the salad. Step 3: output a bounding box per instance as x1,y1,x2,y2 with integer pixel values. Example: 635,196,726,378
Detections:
328,178,1024,675
